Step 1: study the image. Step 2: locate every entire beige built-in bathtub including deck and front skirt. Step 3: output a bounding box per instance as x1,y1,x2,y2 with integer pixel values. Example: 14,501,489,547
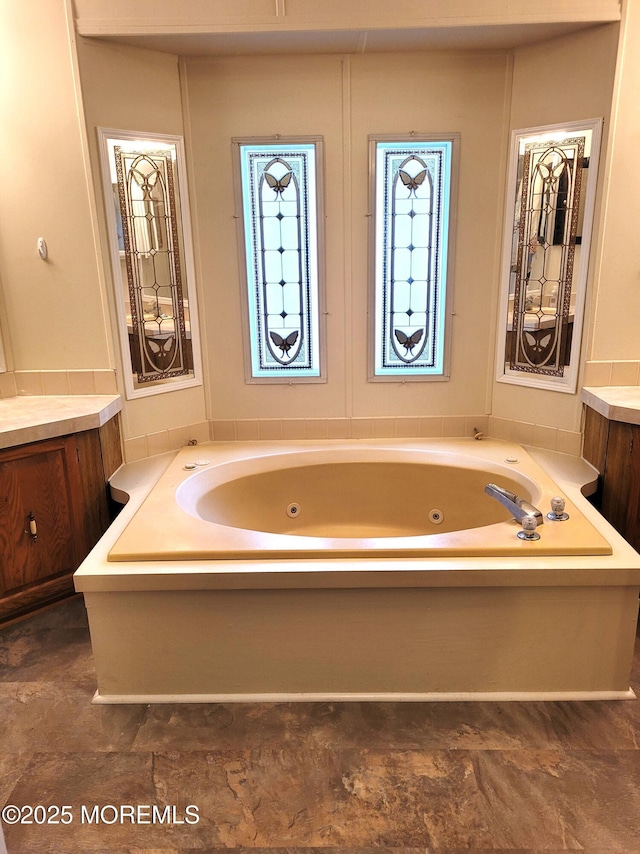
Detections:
75,439,640,703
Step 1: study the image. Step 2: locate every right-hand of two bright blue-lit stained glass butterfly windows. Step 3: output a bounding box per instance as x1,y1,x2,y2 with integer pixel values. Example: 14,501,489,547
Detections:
371,137,456,379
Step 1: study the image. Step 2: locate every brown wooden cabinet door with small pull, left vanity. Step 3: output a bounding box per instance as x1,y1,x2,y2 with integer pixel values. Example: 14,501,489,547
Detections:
0,436,84,596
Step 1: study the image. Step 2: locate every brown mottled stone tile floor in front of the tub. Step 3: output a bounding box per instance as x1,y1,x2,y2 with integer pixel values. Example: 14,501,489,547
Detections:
0,597,640,854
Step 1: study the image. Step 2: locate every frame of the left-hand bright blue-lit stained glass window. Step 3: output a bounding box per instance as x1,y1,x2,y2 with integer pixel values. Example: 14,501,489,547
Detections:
231,135,327,385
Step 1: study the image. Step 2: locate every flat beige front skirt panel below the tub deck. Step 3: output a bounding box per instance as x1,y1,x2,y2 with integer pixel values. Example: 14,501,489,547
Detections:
85,587,638,703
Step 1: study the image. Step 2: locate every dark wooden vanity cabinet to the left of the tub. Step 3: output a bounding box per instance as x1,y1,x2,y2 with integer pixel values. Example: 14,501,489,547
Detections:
0,419,122,624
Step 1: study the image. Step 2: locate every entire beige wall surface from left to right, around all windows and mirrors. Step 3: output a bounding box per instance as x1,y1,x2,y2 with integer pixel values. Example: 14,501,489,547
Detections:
0,0,640,452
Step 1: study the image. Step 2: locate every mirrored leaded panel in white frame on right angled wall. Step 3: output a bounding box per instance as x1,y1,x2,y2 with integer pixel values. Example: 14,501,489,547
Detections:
502,122,600,390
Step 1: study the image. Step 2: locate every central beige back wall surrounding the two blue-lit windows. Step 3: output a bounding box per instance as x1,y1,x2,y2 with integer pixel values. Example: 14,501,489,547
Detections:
185,53,510,419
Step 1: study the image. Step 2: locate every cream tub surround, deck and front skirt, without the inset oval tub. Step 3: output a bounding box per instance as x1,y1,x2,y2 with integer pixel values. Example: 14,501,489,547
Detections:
75,440,640,703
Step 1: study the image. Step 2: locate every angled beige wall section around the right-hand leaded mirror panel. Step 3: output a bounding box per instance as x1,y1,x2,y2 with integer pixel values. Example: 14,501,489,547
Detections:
492,24,619,430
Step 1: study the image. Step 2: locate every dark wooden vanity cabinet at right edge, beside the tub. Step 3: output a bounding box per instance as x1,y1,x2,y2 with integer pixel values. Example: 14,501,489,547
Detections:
583,407,640,551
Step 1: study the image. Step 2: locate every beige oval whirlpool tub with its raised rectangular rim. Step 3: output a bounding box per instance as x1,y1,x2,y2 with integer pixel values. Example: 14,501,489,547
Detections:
109,442,611,561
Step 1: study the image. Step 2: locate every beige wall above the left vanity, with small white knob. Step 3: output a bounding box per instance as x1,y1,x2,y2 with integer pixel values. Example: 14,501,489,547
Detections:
0,0,112,370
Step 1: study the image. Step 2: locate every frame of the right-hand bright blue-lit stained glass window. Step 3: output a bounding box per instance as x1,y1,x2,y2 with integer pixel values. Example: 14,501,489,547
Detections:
367,132,461,383
